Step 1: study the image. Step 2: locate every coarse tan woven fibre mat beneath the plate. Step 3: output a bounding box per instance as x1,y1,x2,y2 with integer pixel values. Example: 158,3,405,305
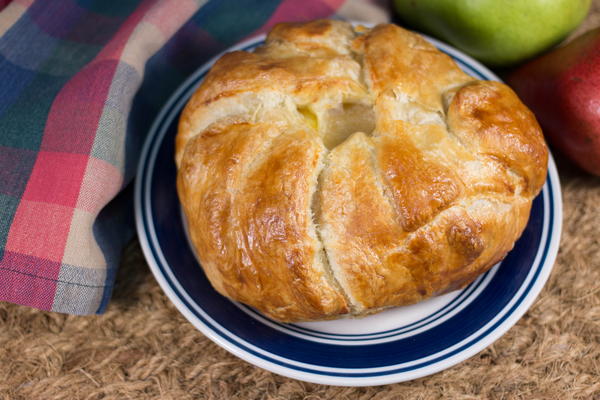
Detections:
0,0,600,400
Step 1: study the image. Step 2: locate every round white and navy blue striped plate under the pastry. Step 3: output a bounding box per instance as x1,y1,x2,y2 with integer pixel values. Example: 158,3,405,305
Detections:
135,32,562,386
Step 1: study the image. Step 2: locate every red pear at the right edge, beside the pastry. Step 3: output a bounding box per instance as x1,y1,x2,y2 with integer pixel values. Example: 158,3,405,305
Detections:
508,28,600,175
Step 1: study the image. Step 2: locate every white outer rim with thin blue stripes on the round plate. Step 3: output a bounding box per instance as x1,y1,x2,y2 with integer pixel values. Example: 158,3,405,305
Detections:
134,29,562,386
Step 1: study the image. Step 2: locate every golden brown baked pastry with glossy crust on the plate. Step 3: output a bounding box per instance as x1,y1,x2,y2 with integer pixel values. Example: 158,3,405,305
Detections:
176,20,548,321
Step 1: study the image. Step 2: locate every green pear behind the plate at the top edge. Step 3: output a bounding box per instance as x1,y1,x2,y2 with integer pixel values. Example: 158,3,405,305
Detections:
394,0,591,67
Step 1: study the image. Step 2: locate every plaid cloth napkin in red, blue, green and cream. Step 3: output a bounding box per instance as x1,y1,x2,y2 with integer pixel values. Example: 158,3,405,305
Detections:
0,0,387,314
